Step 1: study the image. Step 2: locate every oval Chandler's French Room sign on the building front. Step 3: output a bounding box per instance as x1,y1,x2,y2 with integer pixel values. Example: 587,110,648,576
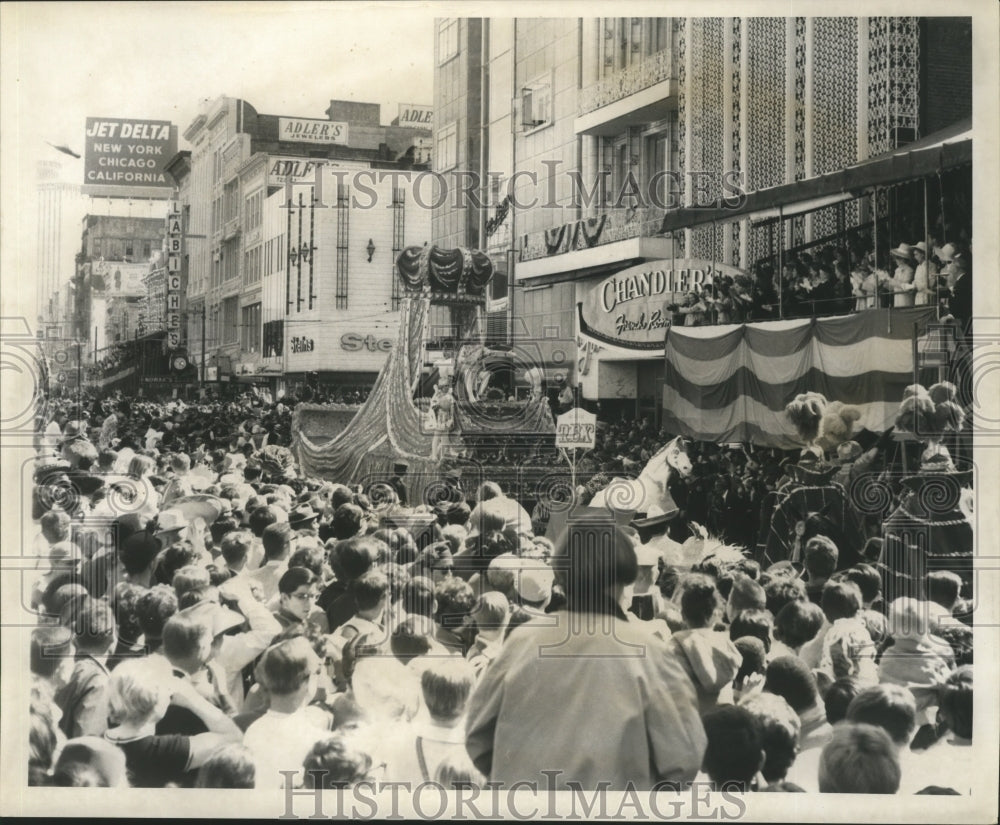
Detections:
578,258,743,350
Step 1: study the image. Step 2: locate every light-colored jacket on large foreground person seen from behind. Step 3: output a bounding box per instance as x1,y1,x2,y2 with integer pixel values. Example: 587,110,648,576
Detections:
466,611,706,790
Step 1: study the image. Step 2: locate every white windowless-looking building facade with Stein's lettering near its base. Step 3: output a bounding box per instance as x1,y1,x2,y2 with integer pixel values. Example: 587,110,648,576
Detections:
256,161,431,393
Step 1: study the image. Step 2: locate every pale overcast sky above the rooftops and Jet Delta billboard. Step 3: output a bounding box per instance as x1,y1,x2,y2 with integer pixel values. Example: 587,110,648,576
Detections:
0,2,440,315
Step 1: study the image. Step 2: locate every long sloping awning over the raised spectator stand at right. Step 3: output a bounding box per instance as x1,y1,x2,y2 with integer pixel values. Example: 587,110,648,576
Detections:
660,118,972,234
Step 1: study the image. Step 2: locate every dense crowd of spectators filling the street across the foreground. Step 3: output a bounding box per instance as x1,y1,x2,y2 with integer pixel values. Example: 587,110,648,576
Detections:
27,394,976,794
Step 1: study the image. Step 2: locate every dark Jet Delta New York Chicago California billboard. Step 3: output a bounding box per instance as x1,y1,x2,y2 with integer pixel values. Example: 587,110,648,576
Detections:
83,117,177,198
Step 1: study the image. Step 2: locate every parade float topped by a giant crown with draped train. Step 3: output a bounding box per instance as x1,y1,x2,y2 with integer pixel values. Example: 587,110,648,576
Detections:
292,241,556,505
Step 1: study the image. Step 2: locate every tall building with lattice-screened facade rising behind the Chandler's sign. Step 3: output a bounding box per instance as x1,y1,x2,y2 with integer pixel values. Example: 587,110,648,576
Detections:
434,17,971,412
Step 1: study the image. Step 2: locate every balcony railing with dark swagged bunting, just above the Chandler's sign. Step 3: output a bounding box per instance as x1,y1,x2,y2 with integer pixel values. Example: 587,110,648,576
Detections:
520,207,663,261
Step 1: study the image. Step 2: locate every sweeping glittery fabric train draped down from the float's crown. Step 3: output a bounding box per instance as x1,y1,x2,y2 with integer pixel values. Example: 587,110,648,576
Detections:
292,298,440,503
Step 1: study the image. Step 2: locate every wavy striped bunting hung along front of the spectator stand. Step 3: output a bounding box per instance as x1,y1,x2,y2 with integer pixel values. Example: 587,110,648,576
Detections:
663,307,935,449
